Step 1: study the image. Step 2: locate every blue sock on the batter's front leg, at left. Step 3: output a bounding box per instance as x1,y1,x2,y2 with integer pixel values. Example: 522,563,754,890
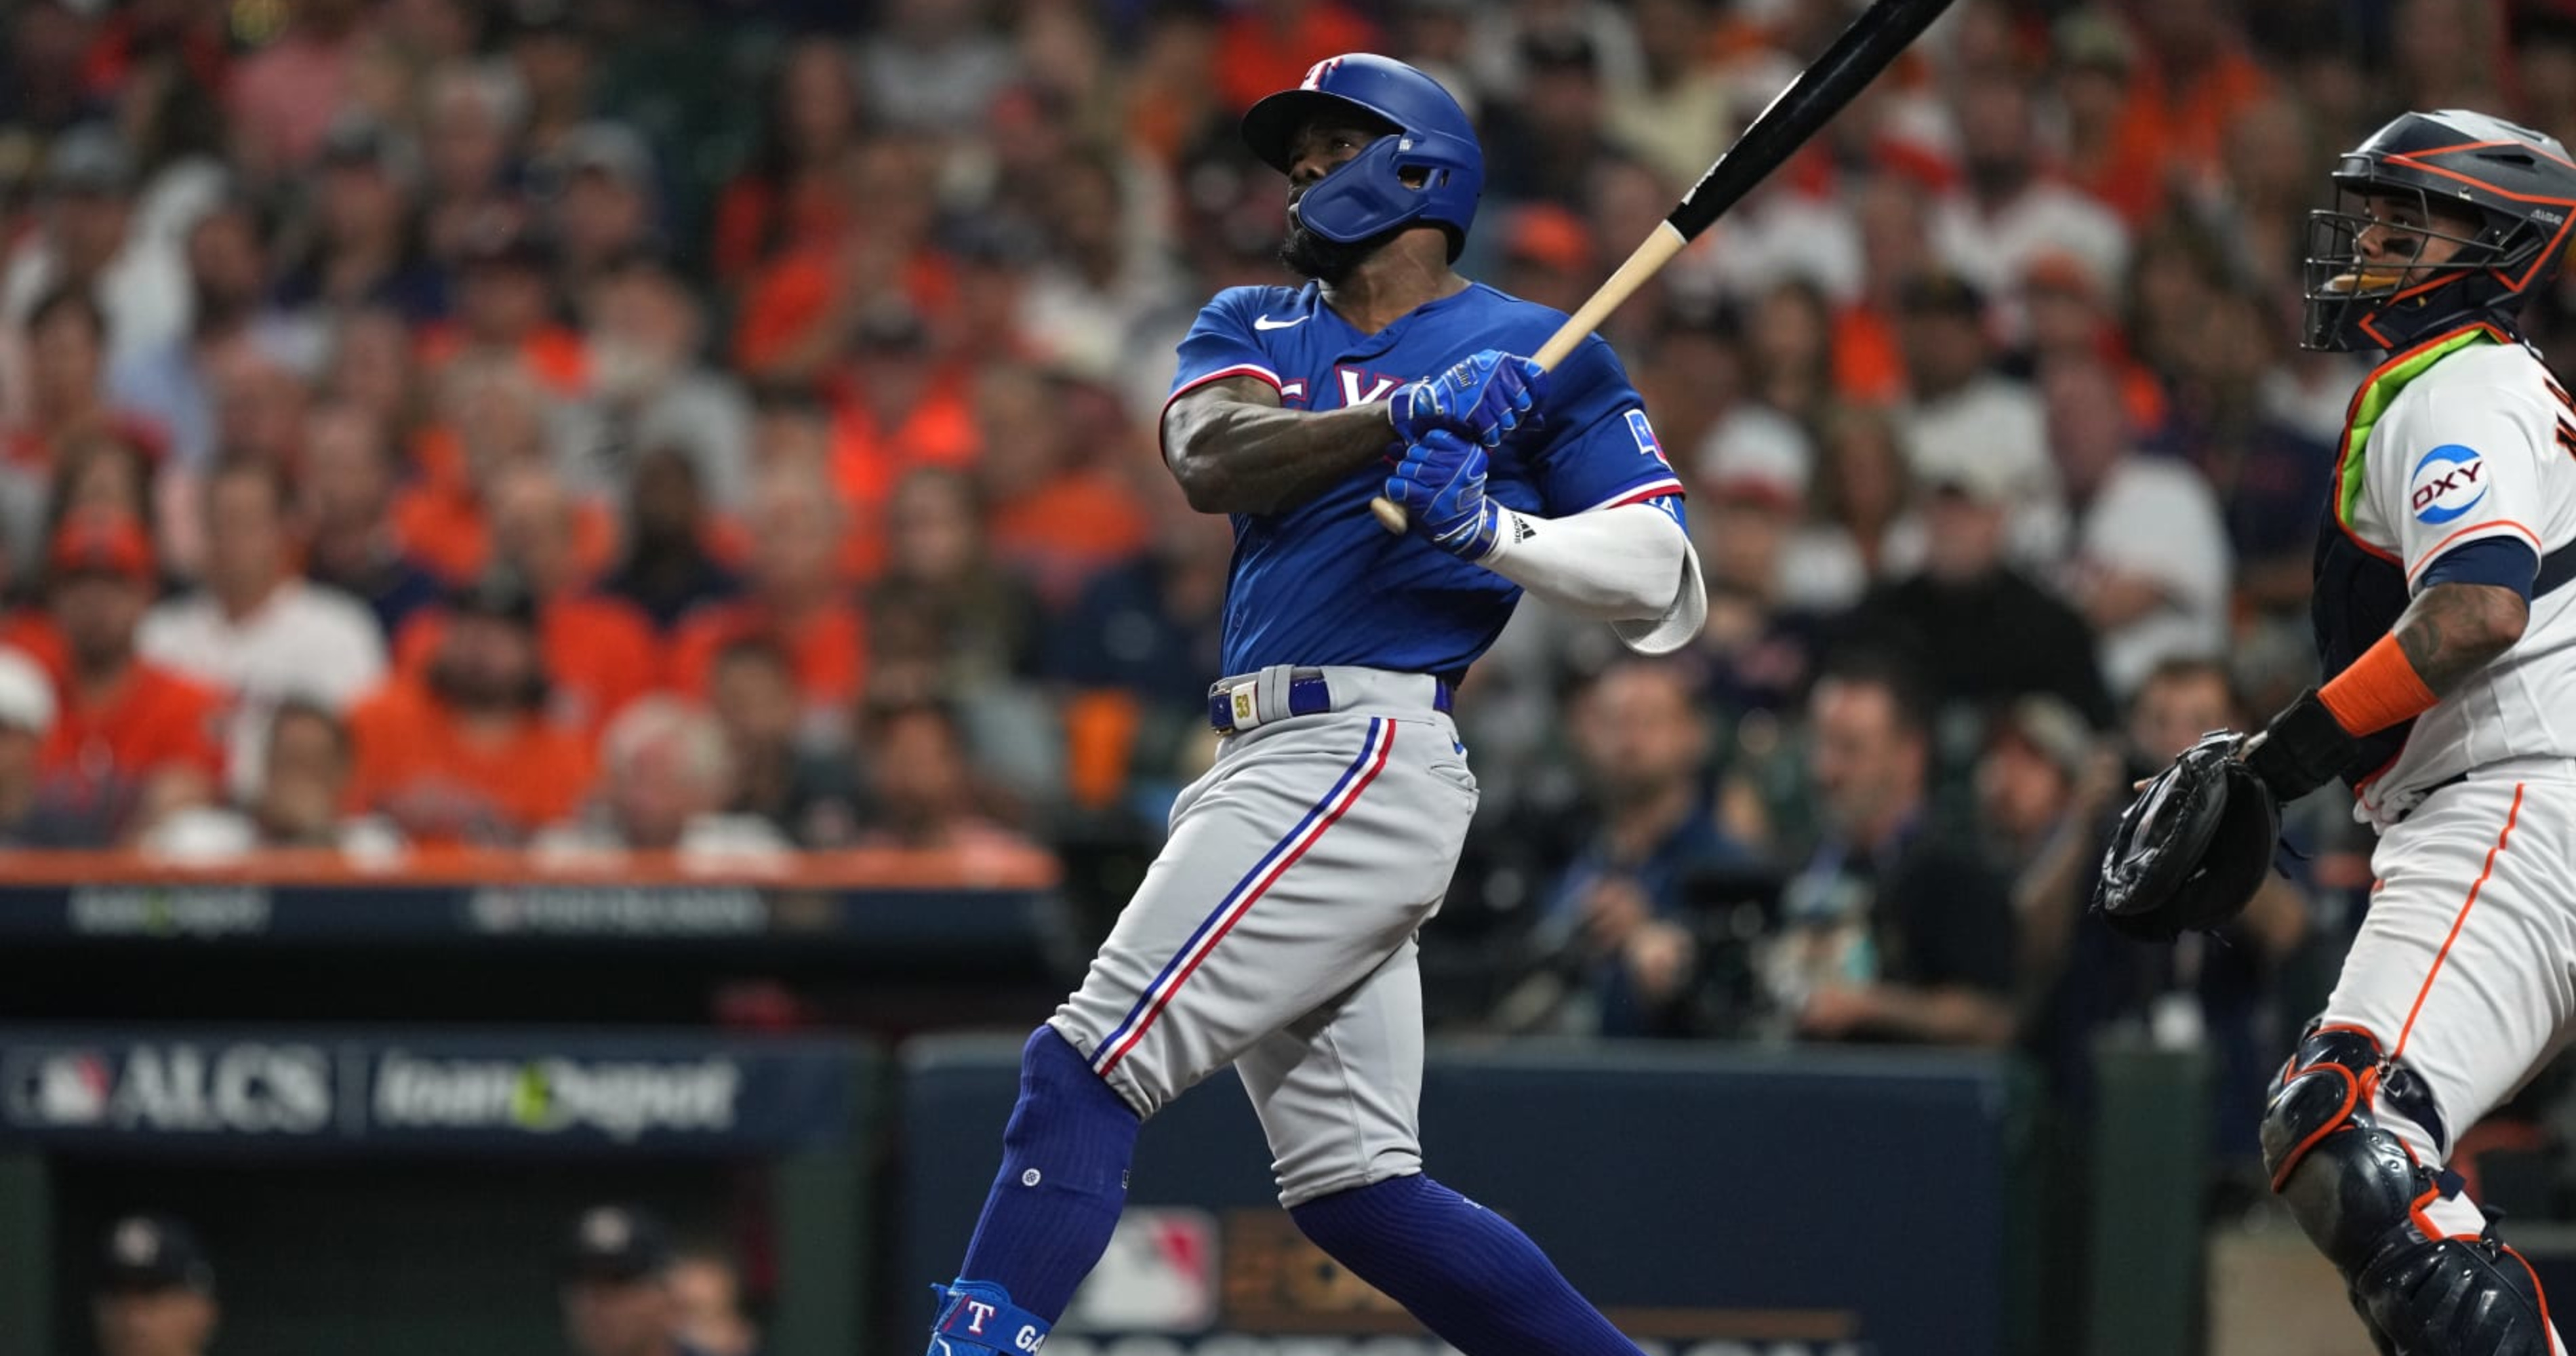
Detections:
938,1026,1144,1325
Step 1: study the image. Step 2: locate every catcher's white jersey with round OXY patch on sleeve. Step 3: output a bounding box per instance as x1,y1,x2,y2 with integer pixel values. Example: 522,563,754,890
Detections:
2337,343,2576,828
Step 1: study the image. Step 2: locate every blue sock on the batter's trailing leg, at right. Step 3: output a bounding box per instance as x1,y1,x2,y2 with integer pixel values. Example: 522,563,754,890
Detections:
1288,1176,1638,1356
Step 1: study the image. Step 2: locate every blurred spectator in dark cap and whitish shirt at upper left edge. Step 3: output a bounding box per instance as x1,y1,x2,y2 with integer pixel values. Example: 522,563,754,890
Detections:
0,124,188,361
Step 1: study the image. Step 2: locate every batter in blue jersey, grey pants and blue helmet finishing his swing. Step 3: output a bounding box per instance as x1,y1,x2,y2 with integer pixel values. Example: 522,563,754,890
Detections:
930,54,1706,1356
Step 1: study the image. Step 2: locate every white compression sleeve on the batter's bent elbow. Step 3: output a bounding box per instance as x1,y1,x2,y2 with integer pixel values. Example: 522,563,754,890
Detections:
1484,502,1708,655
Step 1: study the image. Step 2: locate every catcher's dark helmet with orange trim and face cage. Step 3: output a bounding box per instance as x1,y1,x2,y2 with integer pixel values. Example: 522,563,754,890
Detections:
2300,108,2576,351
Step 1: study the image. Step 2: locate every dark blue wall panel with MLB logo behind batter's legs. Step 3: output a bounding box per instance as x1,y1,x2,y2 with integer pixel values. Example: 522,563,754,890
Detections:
894,1041,2025,1356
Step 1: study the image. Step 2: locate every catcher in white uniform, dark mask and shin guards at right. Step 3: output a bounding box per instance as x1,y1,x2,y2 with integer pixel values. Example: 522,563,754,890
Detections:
2094,111,2576,1356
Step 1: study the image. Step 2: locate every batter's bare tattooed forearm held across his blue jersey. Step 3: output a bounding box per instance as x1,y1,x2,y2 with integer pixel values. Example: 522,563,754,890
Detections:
1162,379,1396,513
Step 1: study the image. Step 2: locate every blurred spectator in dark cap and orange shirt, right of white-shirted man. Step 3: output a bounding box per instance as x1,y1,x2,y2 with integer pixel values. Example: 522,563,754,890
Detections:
350,572,590,845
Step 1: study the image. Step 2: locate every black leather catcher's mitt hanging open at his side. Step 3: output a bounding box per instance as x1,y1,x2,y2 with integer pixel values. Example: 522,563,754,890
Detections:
2094,730,2280,941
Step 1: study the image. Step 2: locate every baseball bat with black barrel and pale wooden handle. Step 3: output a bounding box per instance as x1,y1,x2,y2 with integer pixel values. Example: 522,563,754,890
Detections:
1368,0,1950,531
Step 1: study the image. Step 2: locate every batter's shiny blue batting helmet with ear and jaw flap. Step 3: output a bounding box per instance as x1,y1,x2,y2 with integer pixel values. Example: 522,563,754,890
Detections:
1244,52,1484,260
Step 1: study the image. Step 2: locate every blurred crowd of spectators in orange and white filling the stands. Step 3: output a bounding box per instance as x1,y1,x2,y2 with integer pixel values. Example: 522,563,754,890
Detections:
0,0,2576,1142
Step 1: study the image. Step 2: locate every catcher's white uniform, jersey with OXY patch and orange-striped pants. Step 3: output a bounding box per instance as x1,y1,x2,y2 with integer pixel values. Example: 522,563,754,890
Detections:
2316,330,2576,1263
